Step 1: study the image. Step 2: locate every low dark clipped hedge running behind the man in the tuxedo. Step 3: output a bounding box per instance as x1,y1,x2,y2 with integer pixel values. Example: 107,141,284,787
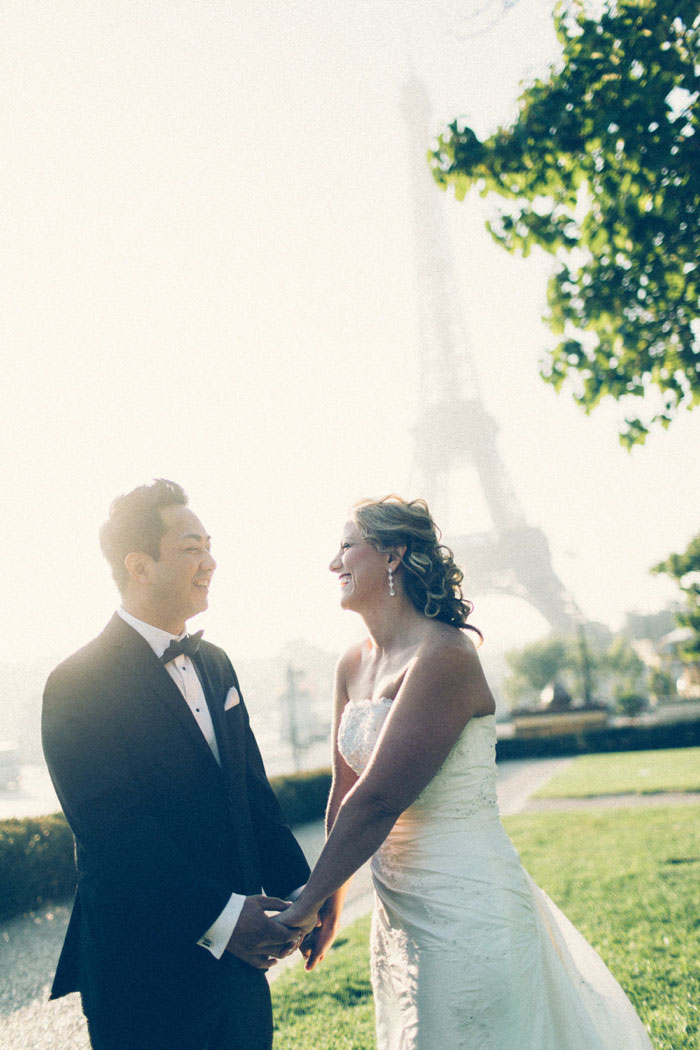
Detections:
0,770,331,920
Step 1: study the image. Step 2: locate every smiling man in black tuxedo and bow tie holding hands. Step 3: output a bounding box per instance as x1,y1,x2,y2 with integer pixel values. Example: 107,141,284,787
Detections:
42,480,309,1050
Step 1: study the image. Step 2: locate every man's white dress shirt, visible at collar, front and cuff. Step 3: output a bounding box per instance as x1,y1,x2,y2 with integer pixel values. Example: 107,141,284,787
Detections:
116,608,246,959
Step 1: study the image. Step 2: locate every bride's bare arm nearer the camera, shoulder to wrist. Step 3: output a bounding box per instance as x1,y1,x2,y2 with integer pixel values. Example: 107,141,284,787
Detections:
279,644,493,928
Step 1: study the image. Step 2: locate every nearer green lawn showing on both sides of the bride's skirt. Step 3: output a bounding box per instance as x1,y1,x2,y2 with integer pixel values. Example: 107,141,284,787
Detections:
272,806,700,1050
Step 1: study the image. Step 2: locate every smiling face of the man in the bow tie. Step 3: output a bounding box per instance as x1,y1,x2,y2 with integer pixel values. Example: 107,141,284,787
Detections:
149,505,216,634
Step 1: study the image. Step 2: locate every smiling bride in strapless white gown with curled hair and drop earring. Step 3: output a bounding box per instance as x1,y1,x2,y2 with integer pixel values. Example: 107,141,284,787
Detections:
279,497,652,1050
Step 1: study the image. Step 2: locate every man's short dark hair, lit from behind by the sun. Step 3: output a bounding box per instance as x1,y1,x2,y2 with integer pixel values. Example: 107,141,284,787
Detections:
100,478,187,591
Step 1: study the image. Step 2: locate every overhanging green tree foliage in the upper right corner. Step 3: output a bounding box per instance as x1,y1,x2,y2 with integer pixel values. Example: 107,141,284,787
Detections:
431,0,700,446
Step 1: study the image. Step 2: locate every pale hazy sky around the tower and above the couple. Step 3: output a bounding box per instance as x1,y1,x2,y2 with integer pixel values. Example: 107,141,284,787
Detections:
0,0,700,659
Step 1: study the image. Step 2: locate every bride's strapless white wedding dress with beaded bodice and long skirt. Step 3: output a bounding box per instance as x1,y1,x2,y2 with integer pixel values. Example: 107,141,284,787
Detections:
338,699,652,1050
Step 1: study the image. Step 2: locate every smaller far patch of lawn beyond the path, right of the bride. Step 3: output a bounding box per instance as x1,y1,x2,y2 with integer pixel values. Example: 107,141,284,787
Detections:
535,748,700,798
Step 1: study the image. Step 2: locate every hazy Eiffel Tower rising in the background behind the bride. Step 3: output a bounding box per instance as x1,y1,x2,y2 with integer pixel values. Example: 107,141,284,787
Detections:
402,75,576,632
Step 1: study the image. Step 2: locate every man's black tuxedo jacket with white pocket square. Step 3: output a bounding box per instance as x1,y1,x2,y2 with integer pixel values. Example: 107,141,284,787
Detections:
42,614,309,1045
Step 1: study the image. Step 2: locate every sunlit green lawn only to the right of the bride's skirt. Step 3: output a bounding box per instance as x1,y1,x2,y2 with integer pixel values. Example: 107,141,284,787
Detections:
504,805,700,1050
